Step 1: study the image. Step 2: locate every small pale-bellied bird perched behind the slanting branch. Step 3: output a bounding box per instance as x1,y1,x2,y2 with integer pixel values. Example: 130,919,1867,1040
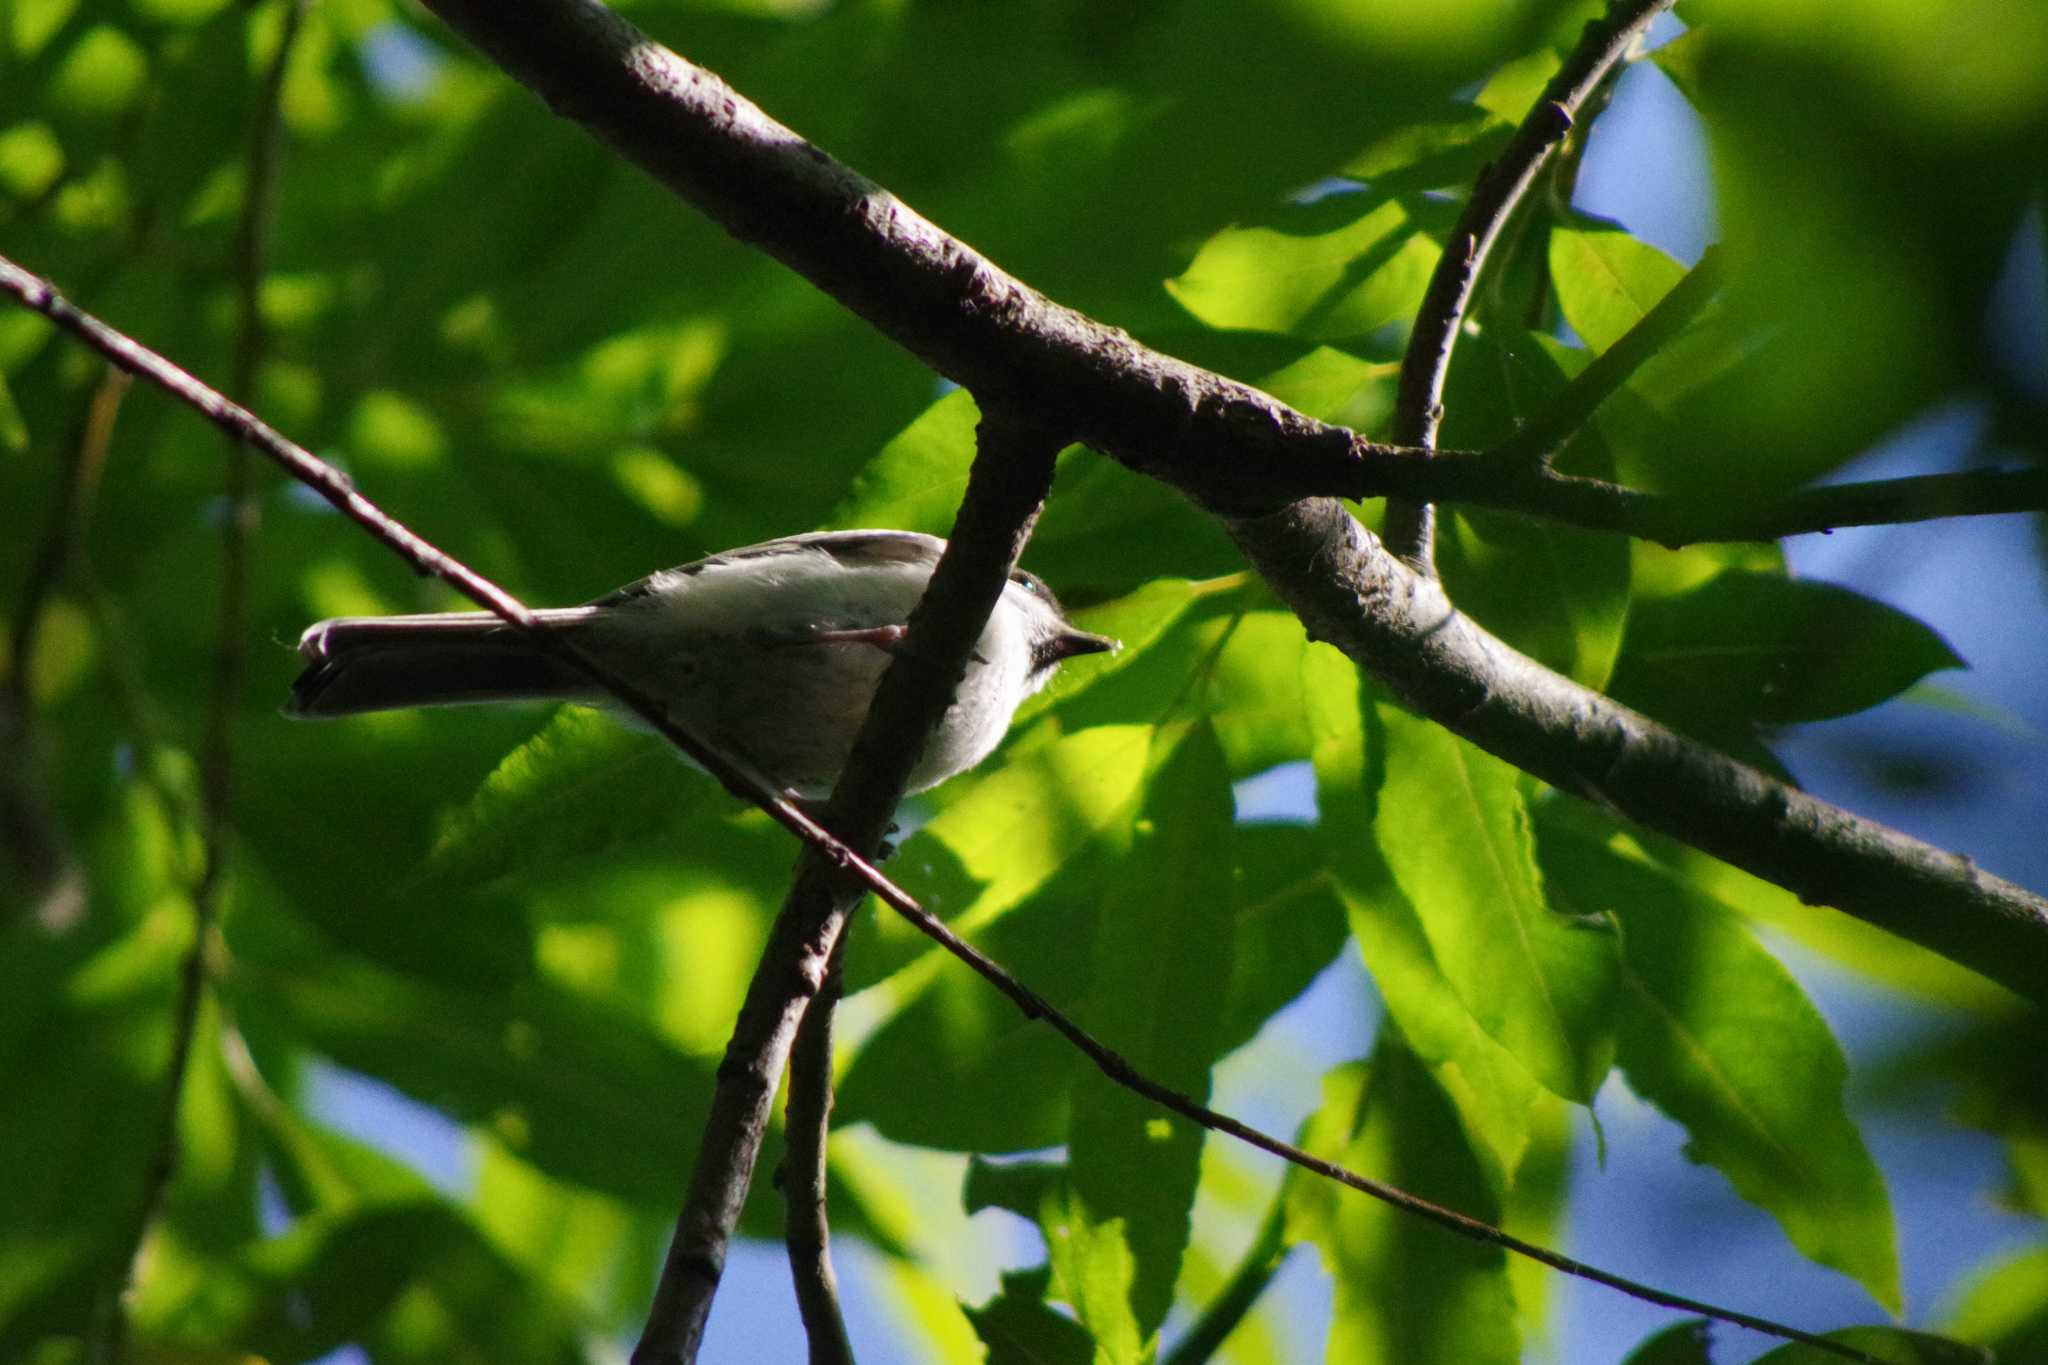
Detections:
285,530,1116,798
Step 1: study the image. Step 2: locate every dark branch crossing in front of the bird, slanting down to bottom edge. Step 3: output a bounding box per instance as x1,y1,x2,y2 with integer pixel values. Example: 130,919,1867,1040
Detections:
633,417,1061,1365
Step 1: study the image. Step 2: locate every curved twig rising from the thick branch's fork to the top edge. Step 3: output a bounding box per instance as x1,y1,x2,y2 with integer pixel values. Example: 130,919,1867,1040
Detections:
1384,0,1671,575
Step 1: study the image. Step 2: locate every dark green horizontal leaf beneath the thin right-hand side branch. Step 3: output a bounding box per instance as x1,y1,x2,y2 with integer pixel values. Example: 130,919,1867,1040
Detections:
1612,571,1964,724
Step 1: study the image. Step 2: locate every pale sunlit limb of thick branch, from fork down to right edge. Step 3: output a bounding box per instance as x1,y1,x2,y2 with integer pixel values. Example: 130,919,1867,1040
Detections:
1229,499,2048,1003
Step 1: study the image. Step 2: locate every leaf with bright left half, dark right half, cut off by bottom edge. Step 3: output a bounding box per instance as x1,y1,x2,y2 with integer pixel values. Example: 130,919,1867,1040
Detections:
1288,1029,1520,1365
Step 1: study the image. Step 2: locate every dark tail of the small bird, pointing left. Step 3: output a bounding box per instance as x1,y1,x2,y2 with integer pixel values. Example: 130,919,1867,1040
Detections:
285,606,596,716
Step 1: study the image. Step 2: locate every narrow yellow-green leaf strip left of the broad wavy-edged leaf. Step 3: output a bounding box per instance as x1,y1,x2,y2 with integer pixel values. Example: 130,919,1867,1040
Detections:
1303,649,1542,1189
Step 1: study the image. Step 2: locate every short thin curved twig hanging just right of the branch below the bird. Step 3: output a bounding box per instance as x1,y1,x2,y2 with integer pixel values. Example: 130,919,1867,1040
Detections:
778,929,854,1365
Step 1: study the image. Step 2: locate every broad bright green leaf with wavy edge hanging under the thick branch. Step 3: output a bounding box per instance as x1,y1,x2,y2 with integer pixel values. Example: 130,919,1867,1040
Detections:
1374,706,1616,1101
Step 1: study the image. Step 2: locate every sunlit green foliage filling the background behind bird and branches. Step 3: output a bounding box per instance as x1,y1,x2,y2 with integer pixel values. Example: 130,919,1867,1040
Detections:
0,0,2048,1361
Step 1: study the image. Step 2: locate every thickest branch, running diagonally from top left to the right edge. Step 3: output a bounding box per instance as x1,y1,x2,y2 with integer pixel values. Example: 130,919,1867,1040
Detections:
407,0,2048,1001
